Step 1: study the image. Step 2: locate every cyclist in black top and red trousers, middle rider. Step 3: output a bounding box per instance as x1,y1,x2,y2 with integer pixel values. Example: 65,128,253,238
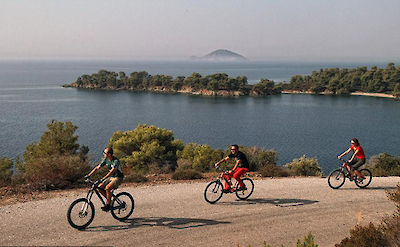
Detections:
215,144,250,192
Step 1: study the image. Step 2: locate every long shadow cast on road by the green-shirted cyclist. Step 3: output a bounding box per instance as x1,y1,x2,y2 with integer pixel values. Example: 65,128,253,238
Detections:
84,217,231,232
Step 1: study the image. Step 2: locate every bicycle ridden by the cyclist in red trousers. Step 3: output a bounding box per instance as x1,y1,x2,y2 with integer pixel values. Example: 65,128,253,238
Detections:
204,168,254,204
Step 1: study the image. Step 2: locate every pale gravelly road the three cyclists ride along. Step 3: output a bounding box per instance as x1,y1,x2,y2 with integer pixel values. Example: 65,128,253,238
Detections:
0,177,400,247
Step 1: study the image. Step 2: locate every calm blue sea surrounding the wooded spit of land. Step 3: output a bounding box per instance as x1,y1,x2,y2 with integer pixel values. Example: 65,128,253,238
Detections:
0,61,400,173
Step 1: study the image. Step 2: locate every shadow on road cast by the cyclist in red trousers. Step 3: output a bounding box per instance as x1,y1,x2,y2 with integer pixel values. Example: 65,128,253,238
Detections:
221,198,318,208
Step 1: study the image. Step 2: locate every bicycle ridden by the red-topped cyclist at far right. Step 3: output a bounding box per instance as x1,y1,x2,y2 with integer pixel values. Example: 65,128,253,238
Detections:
328,159,372,189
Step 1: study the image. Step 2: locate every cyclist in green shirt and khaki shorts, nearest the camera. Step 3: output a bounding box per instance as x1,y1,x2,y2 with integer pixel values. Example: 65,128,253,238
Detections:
85,147,124,212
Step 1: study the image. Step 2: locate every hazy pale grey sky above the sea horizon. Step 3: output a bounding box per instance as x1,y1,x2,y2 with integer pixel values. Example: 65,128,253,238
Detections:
0,0,400,61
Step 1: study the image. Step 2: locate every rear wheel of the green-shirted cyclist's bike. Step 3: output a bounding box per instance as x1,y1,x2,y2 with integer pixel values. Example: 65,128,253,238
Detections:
111,192,135,220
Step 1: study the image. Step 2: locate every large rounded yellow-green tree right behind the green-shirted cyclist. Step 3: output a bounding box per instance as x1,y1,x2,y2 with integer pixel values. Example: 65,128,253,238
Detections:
109,124,183,172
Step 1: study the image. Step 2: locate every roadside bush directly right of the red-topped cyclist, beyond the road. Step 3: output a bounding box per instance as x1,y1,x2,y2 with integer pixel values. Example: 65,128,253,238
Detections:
368,153,400,176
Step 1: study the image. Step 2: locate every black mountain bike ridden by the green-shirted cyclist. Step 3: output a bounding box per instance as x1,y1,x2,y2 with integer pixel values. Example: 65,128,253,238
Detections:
67,178,135,230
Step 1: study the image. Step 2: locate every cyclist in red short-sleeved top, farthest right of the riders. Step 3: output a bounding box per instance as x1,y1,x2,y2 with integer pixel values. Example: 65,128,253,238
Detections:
338,138,365,180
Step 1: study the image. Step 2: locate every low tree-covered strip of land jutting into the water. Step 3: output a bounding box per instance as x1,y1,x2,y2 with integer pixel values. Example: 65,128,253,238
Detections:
63,63,400,98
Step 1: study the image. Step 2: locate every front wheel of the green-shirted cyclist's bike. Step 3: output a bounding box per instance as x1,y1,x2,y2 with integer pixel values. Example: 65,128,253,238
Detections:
67,198,95,230
